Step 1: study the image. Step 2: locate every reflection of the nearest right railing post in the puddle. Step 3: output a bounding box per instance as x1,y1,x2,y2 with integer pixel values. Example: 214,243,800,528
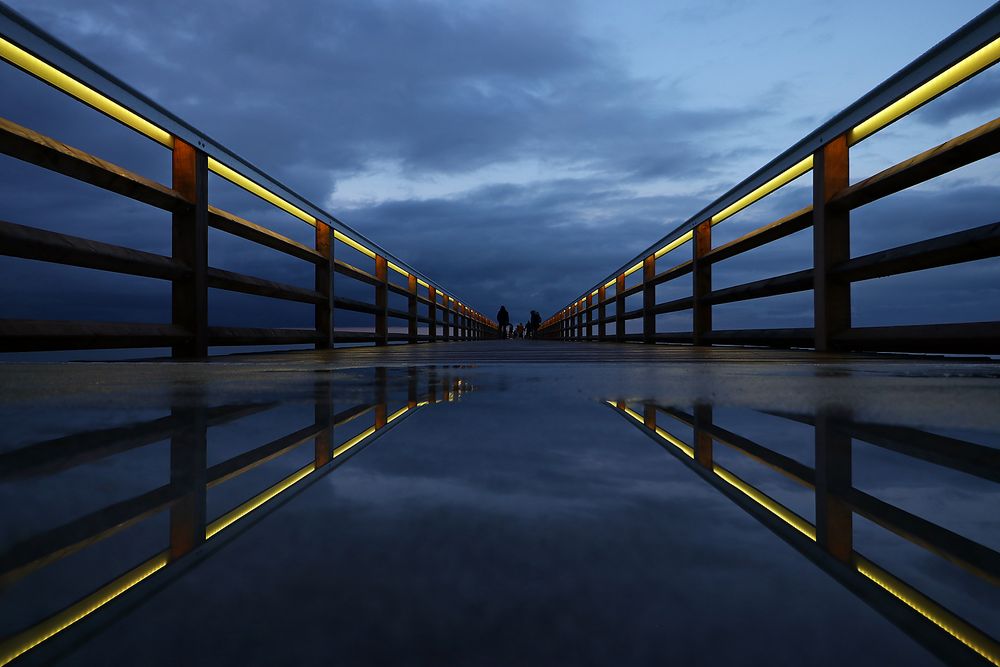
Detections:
815,410,854,563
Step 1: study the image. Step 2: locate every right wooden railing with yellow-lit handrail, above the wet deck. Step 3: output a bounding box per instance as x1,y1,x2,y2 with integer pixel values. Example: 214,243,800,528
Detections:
541,4,1000,354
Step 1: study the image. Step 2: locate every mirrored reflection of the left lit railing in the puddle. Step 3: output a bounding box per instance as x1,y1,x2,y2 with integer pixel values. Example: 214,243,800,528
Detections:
0,368,471,665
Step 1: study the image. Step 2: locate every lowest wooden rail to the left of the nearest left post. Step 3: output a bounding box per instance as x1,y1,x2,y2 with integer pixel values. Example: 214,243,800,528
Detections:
0,319,191,352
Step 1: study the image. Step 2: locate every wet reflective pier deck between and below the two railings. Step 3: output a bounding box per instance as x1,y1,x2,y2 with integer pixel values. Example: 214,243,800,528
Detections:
0,341,1000,665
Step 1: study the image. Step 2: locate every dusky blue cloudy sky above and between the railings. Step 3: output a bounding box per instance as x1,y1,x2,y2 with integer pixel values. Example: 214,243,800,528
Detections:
0,0,1000,344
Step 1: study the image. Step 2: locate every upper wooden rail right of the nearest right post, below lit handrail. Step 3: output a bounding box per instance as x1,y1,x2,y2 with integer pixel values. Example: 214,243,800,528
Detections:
832,118,1000,209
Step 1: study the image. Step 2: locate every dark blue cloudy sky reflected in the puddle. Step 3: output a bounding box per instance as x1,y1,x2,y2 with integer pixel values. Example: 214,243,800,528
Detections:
0,361,1000,665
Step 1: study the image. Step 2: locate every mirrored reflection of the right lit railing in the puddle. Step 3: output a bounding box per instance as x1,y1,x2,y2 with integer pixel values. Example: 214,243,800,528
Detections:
608,401,1000,665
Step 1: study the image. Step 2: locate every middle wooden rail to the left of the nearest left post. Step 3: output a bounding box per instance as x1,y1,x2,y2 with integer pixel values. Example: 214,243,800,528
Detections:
0,221,190,280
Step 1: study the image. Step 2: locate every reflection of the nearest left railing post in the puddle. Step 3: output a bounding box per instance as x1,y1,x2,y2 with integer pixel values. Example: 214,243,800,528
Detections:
170,391,208,560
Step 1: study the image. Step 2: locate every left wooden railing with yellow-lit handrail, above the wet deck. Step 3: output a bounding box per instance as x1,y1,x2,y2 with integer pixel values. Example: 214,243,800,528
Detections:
0,4,496,357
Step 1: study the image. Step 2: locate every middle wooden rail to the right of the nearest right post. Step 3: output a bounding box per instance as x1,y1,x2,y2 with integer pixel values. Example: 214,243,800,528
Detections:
833,222,1000,281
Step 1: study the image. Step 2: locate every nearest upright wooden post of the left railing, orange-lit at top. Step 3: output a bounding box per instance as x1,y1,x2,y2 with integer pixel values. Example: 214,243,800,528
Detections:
171,138,208,358
